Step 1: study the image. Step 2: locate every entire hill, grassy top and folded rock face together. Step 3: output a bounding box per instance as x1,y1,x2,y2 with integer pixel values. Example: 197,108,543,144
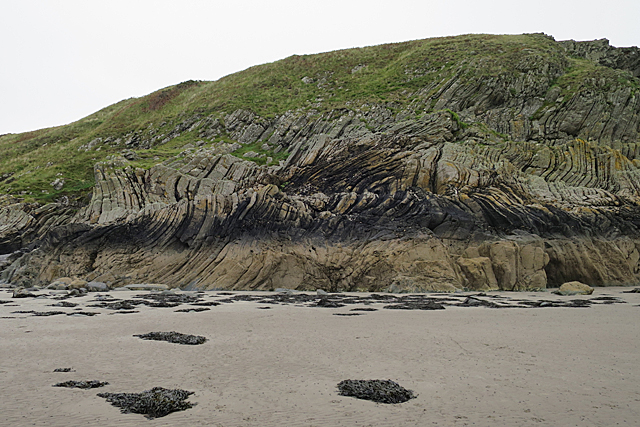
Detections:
0,34,640,290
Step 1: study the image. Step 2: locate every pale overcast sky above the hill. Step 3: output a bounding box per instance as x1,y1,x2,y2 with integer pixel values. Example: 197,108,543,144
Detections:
0,0,640,135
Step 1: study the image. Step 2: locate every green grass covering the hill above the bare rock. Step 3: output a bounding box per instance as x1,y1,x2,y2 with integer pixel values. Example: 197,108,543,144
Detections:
0,34,640,205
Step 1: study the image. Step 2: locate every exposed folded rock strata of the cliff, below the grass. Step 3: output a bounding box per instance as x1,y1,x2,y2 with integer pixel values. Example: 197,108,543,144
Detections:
0,35,640,291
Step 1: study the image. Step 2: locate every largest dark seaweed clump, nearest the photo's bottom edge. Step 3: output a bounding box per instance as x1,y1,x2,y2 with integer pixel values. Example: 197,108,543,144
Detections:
98,387,195,419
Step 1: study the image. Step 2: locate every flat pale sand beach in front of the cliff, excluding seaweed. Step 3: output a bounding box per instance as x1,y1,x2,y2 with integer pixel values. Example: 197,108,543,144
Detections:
0,288,640,427
